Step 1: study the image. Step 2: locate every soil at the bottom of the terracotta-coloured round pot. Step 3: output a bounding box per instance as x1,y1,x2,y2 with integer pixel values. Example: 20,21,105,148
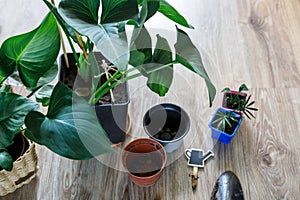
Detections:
126,151,163,177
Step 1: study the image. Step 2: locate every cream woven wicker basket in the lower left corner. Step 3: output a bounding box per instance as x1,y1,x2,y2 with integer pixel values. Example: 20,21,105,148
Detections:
0,142,38,196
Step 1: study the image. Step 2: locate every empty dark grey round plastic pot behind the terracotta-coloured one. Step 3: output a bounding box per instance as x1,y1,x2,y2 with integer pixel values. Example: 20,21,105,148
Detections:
143,103,190,153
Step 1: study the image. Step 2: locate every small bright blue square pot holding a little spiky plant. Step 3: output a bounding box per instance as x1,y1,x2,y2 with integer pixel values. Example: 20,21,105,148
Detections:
208,108,242,144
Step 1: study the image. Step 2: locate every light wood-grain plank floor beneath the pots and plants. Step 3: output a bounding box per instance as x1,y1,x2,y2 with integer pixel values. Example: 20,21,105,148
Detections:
0,0,300,200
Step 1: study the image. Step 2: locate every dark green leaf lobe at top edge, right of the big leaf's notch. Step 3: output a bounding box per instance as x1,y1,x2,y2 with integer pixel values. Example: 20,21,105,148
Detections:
101,0,138,23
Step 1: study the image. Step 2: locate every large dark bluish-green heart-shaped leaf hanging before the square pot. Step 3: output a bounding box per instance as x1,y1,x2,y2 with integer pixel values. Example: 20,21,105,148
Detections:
25,82,112,160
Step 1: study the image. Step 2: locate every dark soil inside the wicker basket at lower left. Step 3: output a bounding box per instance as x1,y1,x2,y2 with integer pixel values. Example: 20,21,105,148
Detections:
0,133,29,171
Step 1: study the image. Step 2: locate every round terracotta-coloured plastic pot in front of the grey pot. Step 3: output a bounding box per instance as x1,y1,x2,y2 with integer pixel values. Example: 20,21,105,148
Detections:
122,138,167,187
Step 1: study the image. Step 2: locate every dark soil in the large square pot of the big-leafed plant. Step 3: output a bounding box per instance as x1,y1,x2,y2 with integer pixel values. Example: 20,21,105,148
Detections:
60,53,128,105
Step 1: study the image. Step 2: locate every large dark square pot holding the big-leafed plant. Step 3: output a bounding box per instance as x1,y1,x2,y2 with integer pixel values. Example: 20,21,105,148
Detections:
59,52,130,144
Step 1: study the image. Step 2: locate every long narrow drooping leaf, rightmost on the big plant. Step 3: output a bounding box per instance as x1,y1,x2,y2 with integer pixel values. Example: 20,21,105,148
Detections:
175,28,216,106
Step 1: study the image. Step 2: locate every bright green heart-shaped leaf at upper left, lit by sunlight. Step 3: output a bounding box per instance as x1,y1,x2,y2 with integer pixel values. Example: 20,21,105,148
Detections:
0,13,60,88
